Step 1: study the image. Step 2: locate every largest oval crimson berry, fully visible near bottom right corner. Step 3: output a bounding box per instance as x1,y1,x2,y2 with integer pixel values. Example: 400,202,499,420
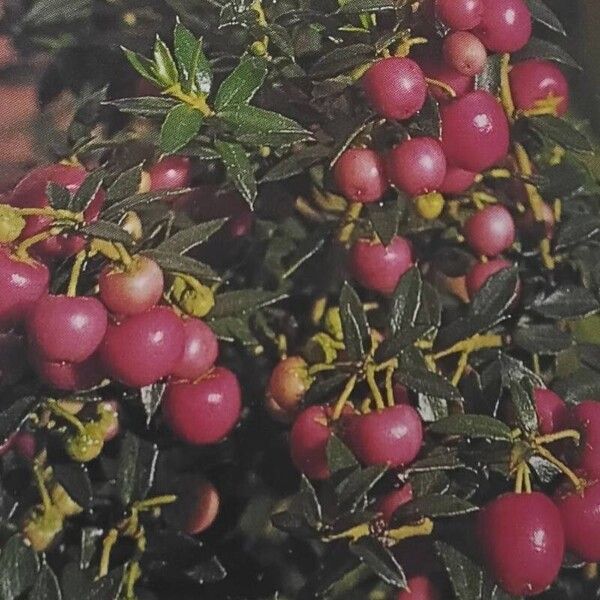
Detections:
477,492,565,596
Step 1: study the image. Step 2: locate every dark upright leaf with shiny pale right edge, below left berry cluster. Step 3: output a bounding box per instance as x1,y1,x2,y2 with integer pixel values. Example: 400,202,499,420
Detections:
116,431,158,506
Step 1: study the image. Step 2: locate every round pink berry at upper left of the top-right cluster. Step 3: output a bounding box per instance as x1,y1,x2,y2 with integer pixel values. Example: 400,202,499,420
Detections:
362,57,427,120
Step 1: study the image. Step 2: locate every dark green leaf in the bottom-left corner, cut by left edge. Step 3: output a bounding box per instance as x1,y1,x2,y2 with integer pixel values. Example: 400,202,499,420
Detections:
0,535,38,600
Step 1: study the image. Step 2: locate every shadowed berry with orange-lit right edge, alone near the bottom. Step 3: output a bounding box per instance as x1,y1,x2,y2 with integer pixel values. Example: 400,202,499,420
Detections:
164,475,220,535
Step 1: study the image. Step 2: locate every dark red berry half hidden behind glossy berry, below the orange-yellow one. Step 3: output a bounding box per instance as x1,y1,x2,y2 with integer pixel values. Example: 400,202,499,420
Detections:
290,406,331,481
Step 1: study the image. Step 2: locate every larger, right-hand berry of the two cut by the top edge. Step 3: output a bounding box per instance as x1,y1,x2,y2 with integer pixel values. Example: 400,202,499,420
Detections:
474,0,532,52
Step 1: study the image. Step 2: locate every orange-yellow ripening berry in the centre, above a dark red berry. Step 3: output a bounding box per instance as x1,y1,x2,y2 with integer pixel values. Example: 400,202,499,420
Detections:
266,356,312,423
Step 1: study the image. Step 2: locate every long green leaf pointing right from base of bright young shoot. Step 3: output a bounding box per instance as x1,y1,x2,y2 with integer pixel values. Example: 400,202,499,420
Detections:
217,104,311,146
